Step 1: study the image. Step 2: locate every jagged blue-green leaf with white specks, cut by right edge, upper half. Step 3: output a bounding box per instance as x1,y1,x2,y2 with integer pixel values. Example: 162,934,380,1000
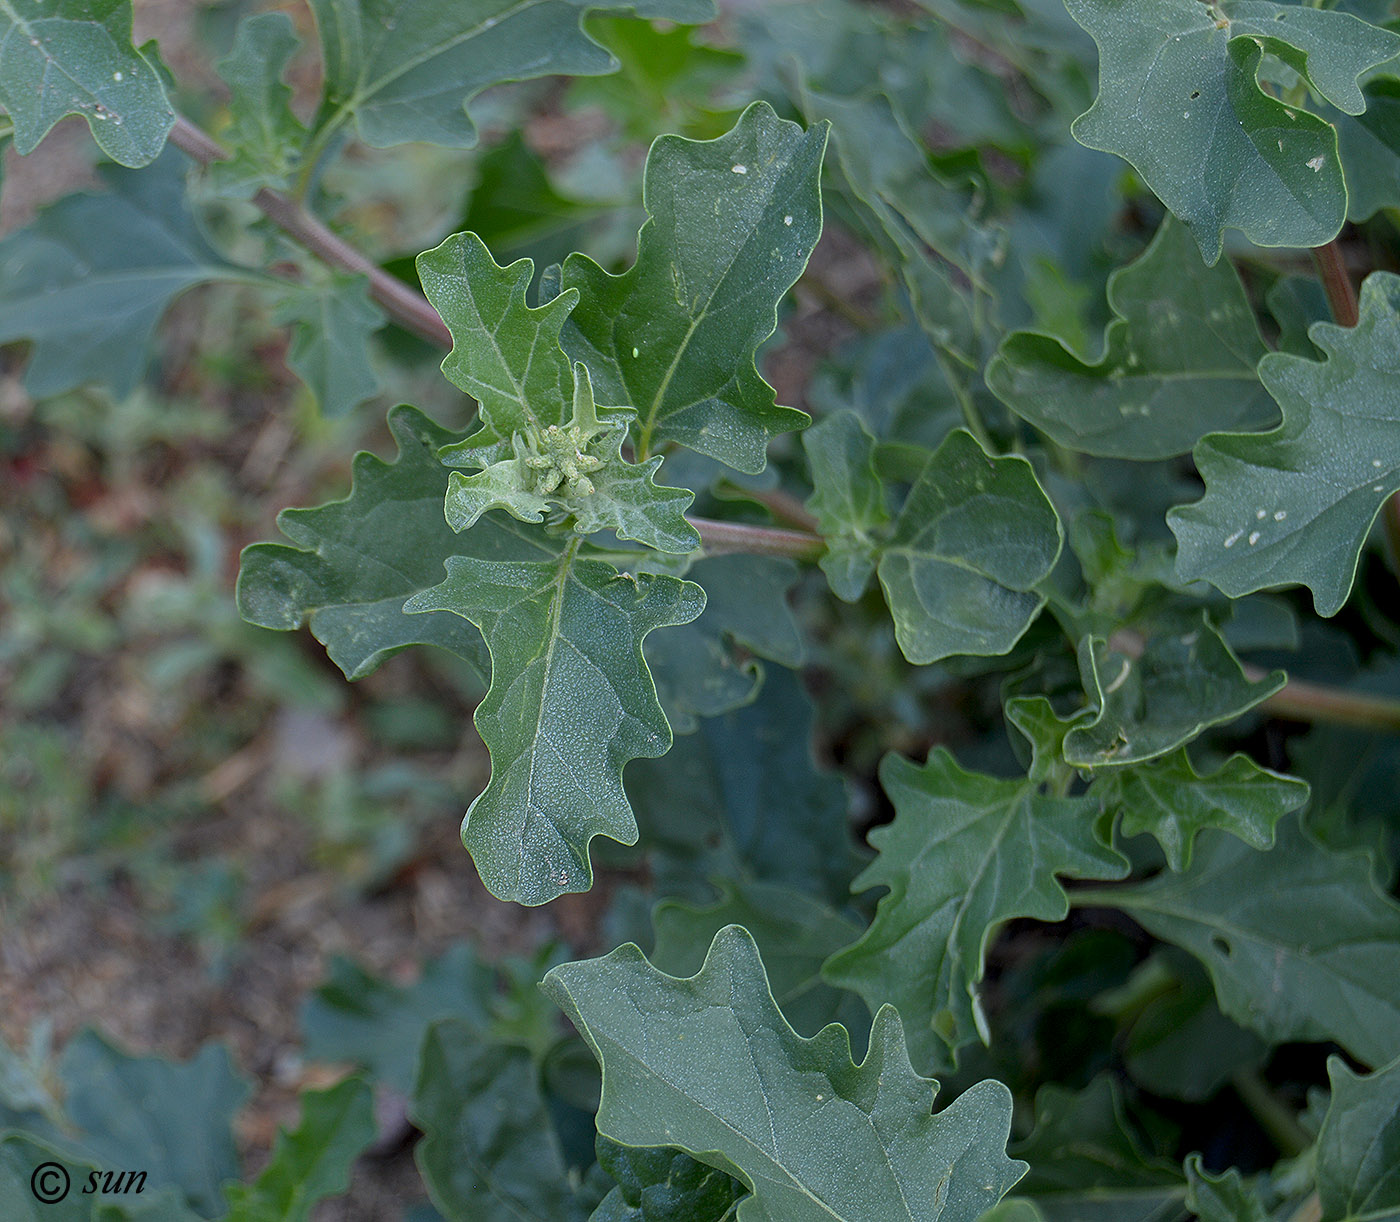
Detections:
1168,272,1400,616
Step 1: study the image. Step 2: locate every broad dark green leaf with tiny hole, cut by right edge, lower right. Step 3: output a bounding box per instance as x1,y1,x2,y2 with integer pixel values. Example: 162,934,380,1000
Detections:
1075,820,1400,1065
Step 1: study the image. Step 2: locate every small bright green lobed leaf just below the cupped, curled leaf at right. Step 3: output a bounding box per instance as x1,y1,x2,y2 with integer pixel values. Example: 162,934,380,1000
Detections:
1093,747,1308,871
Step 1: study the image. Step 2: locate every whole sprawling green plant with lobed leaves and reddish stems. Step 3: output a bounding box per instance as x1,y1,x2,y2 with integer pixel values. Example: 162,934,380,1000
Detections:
0,0,1400,1222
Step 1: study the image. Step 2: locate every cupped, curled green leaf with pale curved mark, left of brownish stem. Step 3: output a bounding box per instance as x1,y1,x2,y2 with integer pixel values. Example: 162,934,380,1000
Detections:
1064,612,1287,768
